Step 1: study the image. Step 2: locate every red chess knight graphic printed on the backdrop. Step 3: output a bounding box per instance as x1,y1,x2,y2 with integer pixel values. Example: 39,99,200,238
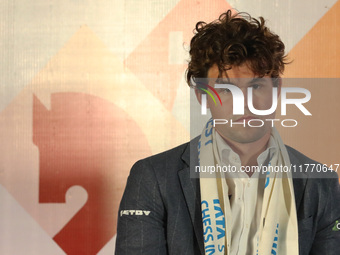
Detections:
33,93,150,255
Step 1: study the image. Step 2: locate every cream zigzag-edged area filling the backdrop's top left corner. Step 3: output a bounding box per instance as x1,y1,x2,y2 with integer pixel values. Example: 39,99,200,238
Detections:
0,0,179,111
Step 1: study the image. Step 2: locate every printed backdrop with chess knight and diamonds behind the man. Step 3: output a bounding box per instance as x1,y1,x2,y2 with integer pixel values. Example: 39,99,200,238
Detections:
0,0,340,255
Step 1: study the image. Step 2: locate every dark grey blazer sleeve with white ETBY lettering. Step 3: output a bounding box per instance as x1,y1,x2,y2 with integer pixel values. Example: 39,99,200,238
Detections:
115,159,167,255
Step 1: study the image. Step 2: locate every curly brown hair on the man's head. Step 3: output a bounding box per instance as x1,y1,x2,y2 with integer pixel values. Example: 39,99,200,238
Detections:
186,10,287,85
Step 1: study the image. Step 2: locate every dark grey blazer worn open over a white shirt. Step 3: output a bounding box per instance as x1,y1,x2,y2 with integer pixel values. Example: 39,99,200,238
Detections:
115,143,340,255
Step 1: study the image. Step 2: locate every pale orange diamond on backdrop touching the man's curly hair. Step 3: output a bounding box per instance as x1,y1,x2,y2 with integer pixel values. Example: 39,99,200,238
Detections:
125,0,231,110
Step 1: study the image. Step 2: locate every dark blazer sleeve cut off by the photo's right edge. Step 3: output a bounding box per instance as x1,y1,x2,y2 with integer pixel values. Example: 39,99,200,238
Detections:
310,178,340,255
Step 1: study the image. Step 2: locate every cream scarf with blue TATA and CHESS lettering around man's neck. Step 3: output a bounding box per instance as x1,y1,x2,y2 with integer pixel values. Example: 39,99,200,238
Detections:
198,120,299,255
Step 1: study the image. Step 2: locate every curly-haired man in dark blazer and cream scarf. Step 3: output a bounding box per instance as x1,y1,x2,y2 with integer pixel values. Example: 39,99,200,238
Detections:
116,11,340,255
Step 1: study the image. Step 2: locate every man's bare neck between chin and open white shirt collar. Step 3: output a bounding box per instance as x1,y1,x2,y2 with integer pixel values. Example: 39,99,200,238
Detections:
221,130,270,166
